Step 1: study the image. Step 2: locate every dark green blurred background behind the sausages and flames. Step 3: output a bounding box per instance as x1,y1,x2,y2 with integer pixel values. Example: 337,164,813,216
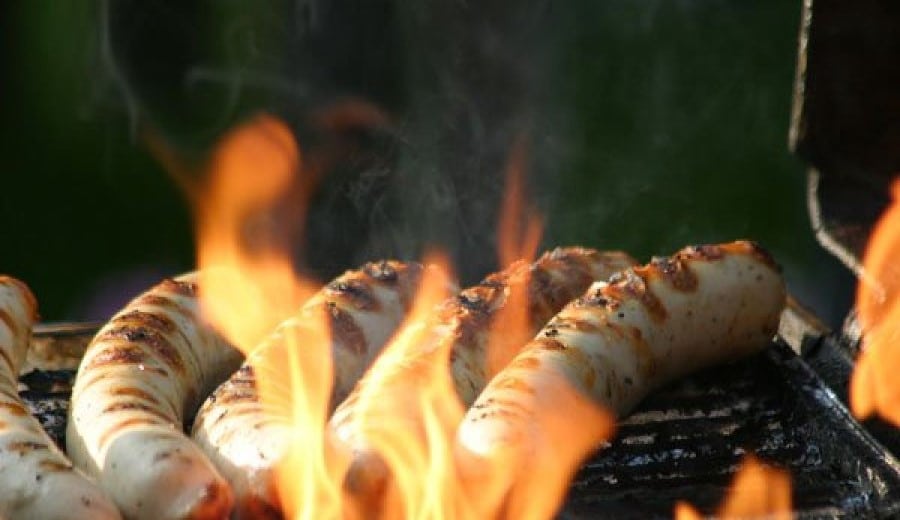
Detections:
0,0,852,324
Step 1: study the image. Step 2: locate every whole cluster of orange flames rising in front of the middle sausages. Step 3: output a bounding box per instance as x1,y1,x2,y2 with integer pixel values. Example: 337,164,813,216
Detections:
192,116,596,519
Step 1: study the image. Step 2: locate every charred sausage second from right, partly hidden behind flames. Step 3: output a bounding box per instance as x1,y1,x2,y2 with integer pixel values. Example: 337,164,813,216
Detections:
330,247,634,501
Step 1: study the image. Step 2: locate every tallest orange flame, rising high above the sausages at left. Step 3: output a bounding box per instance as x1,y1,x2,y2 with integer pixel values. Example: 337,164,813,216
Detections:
197,116,340,519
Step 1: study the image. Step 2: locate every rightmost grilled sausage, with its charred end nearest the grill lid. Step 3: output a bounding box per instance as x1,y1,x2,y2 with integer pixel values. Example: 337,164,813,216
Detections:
456,241,785,517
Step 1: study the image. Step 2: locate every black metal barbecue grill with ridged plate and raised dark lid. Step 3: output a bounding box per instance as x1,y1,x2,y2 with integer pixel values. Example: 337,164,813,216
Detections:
14,0,900,519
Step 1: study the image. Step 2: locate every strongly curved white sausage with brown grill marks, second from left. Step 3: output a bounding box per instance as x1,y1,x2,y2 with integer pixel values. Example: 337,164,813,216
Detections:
66,273,243,520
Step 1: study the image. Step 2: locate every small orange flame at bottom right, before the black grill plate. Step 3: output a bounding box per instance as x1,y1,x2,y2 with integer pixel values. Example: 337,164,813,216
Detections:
675,455,792,520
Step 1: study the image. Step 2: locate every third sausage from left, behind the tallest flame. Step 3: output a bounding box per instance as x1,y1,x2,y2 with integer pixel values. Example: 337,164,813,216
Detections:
193,261,422,518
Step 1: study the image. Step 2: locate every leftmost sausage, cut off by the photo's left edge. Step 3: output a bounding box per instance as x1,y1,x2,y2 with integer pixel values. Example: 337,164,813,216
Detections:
0,276,120,520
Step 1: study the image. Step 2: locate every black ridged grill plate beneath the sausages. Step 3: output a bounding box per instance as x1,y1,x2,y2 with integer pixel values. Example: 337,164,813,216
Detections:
15,342,900,519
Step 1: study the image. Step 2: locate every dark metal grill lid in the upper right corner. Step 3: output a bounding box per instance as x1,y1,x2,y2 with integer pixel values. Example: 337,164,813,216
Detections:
790,0,900,274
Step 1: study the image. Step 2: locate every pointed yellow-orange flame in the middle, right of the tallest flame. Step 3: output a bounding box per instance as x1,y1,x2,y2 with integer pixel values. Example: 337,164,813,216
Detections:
346,250,463,519
